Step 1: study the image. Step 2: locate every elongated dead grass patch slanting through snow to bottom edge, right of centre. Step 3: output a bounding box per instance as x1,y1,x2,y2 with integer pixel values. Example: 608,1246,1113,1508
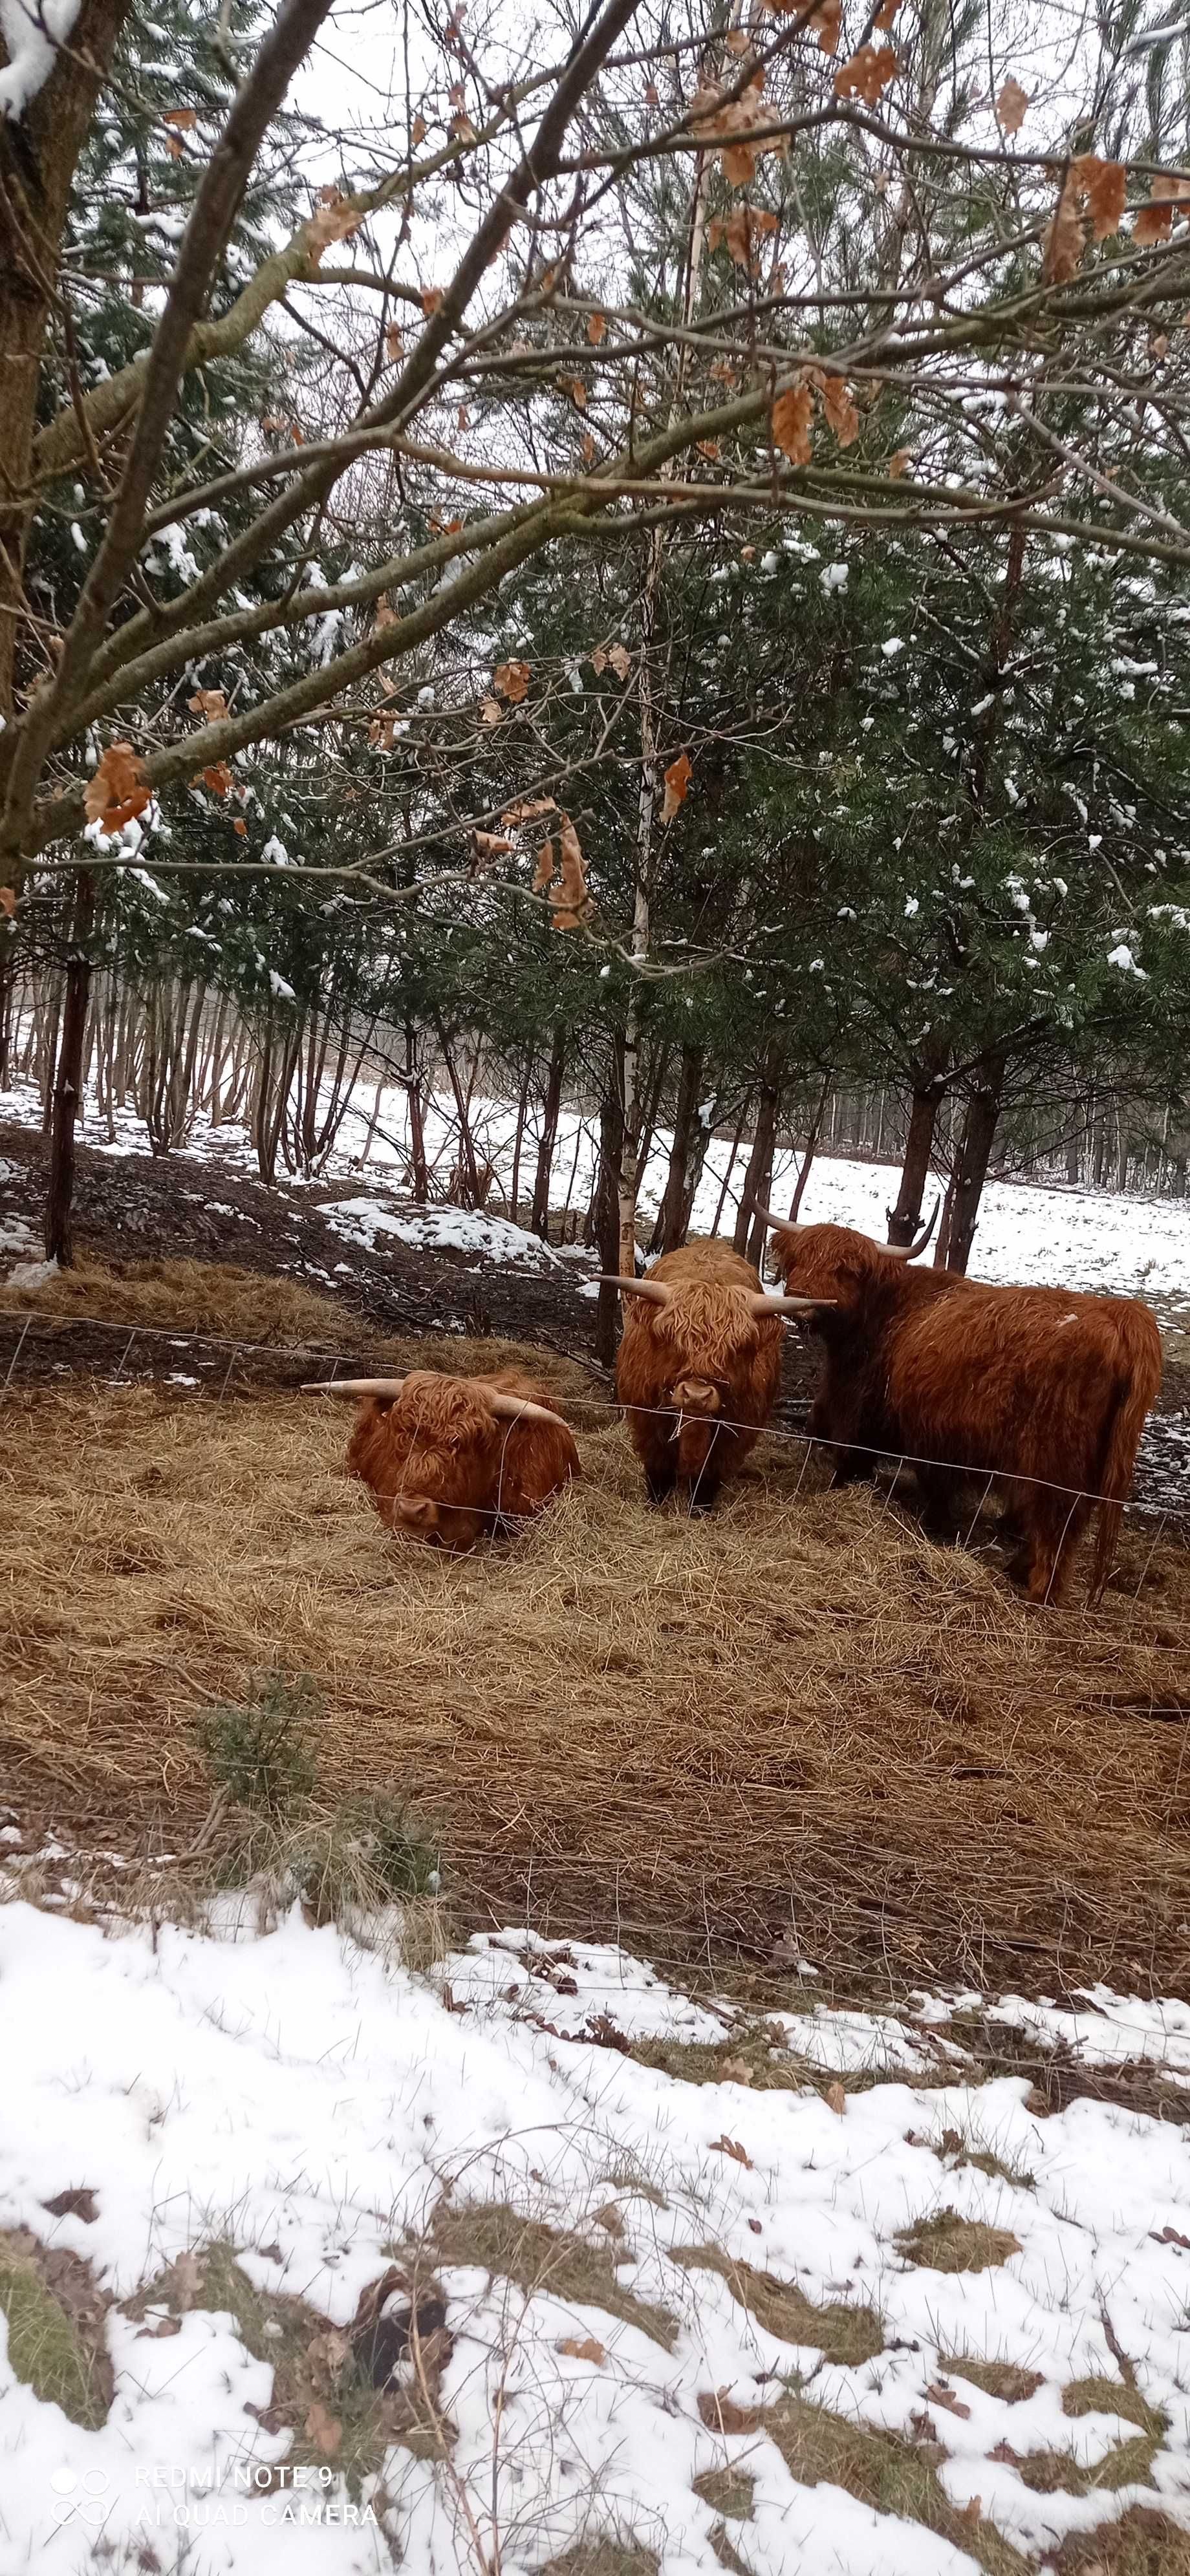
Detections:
763,2393,1025,2576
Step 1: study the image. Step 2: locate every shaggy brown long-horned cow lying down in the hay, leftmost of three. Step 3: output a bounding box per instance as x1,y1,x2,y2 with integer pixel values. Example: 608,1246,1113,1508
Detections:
306,1368,582,1556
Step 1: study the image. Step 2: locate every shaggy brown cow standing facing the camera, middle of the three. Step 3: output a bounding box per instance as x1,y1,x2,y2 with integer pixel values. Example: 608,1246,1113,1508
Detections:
603,1241,829,1512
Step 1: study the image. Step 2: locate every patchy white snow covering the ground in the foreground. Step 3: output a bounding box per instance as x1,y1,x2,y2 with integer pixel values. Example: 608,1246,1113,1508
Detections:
0,1901,1190,2576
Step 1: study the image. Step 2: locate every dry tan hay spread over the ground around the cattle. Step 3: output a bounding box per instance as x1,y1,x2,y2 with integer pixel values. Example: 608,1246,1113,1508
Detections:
0,1298,1190,1991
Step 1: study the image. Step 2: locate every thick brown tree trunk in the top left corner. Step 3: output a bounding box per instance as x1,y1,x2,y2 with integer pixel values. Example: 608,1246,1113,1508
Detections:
0,0,131,736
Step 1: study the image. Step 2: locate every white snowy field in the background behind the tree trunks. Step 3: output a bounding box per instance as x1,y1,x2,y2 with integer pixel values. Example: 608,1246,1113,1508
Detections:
0,1084,1190,1324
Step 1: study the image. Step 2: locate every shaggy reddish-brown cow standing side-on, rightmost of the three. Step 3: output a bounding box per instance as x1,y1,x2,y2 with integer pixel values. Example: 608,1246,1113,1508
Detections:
763,1210,1162,1602
